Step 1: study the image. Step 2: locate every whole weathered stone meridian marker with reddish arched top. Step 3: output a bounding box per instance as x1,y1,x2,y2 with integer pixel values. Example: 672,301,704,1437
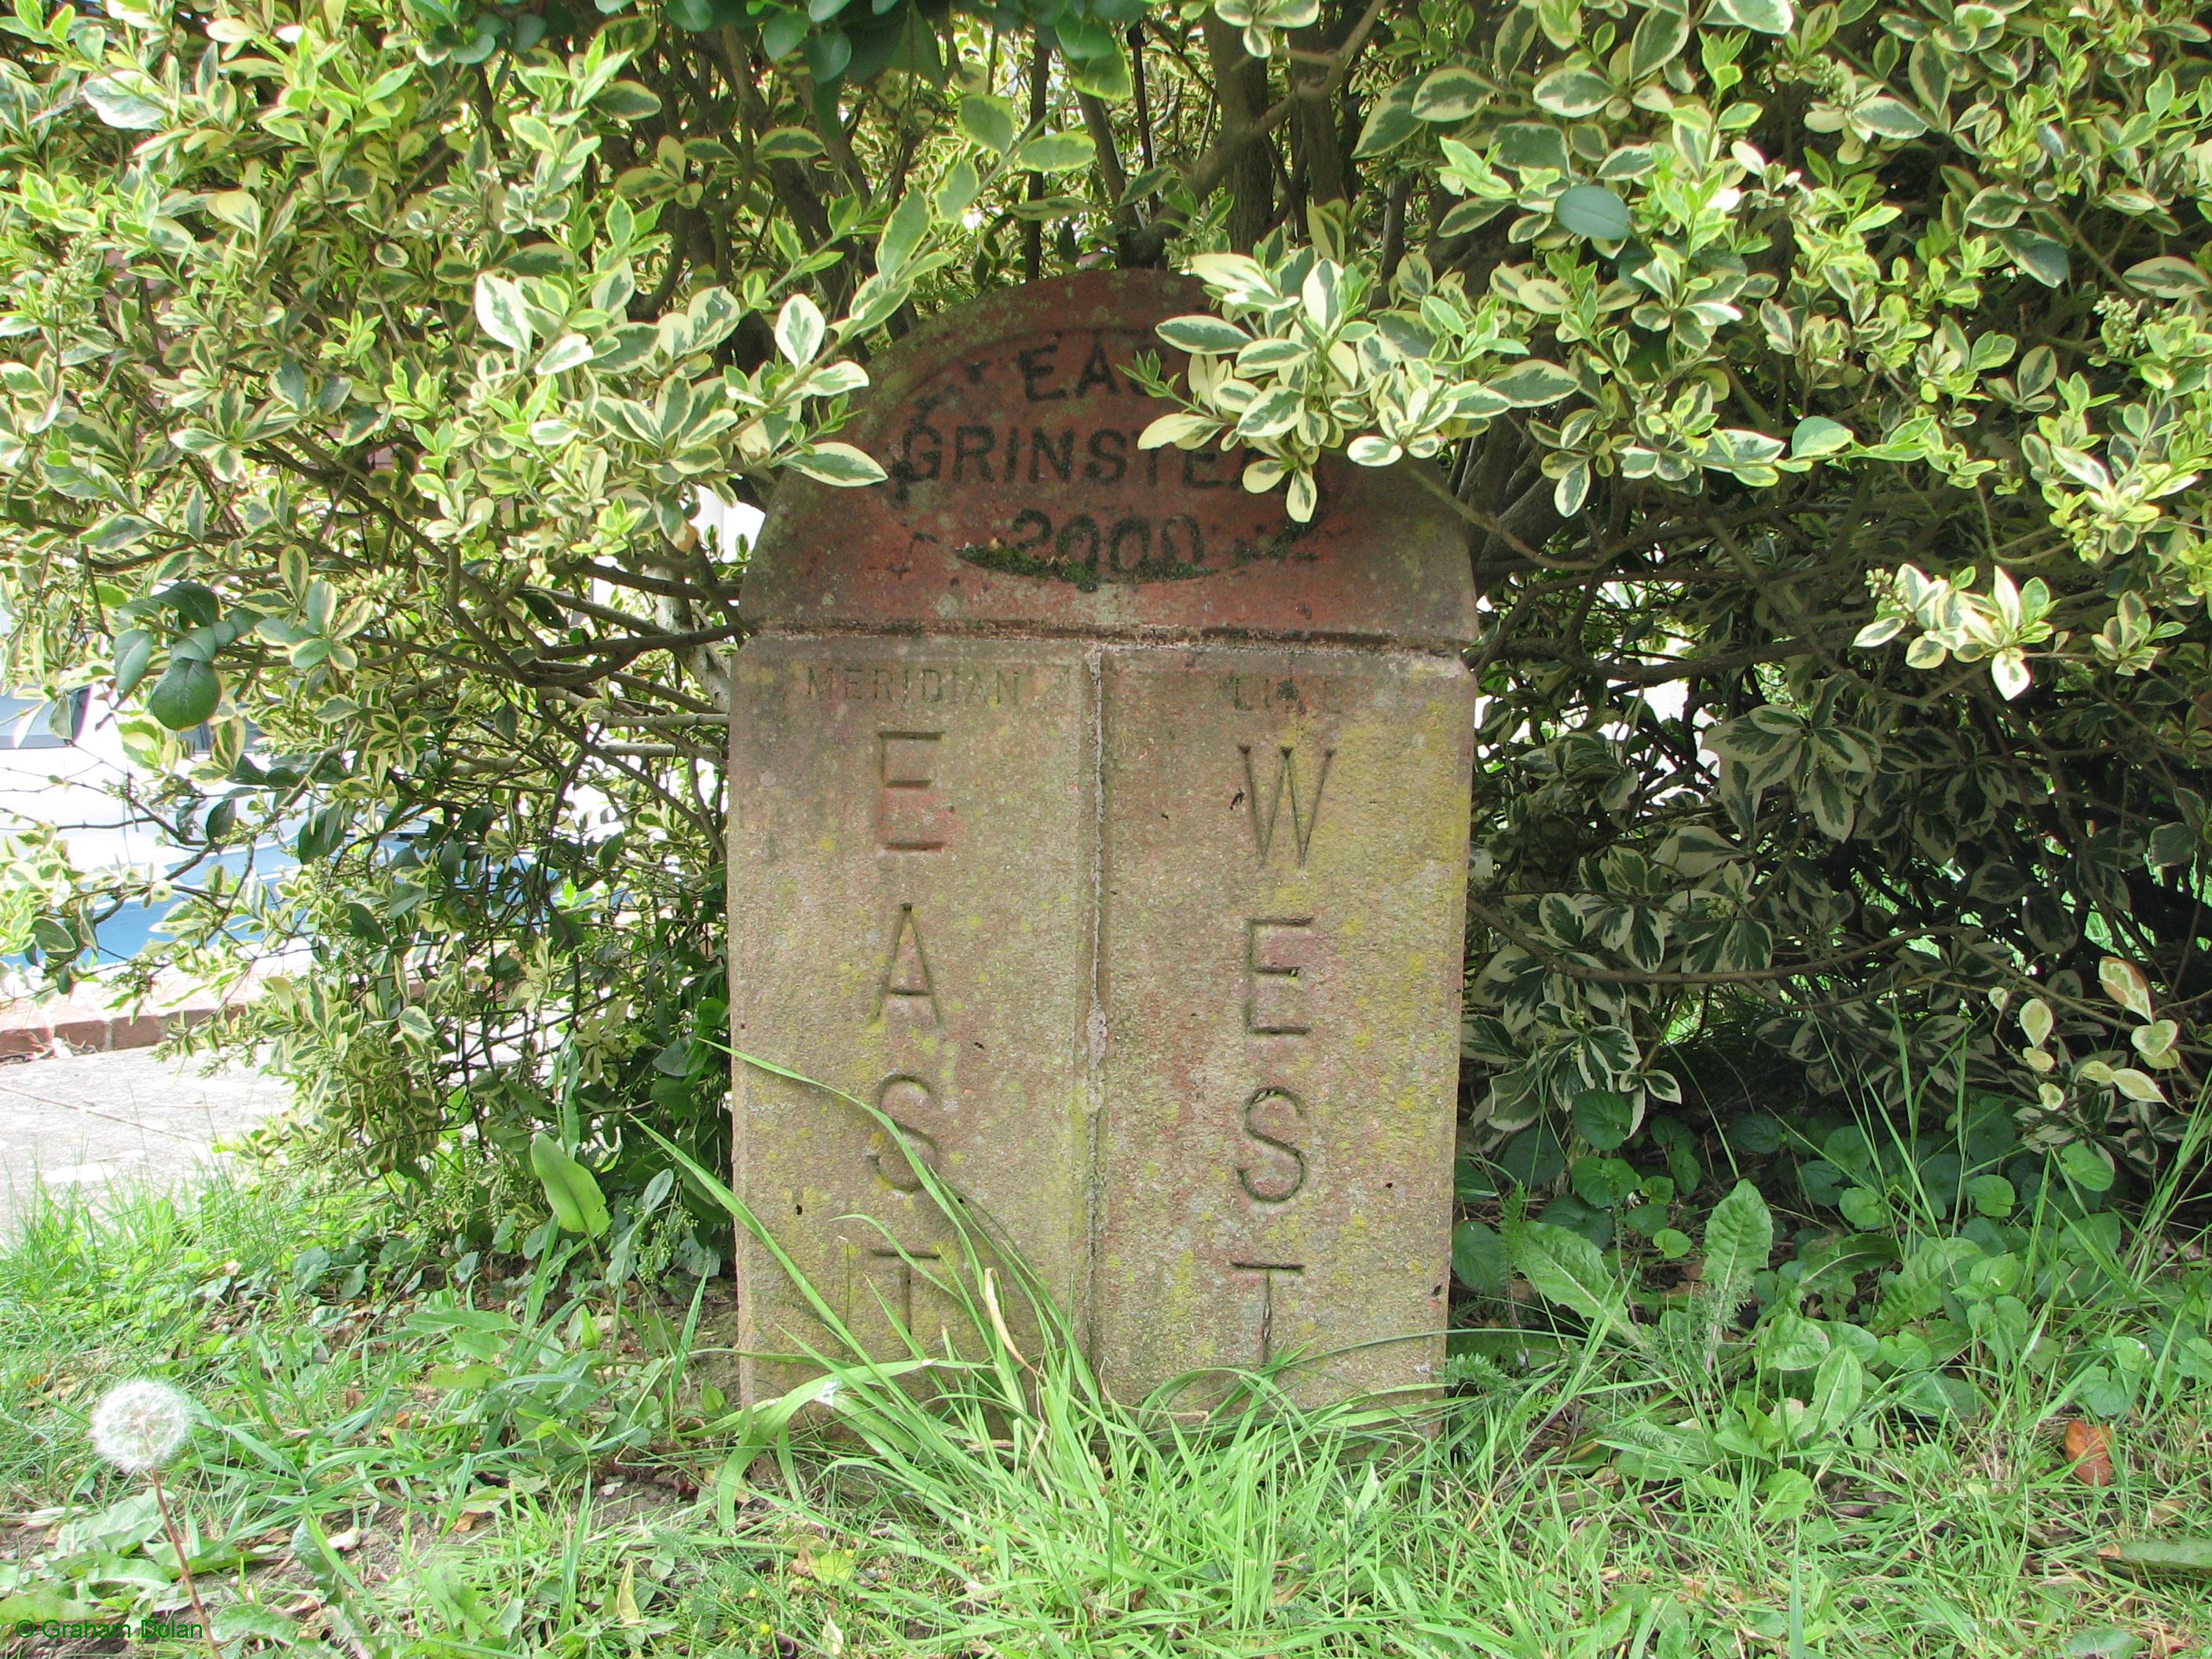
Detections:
730,272,1475,1401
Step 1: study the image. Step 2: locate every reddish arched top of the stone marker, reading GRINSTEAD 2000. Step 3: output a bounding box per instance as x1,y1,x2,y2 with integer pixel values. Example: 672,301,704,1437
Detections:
743,272,1475,650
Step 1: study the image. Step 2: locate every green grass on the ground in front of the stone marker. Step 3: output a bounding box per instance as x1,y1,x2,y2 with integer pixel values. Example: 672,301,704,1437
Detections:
0,1172,2212,1659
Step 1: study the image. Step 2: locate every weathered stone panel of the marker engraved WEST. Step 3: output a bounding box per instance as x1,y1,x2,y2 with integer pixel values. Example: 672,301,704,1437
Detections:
1095,648,1473,1396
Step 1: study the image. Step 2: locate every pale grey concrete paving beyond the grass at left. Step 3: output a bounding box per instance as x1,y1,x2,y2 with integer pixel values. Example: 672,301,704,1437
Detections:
0,1049,290,1234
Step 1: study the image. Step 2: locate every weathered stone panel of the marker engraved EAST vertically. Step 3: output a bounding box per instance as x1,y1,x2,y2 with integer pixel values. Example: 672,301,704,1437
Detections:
730,635,1095,1389
